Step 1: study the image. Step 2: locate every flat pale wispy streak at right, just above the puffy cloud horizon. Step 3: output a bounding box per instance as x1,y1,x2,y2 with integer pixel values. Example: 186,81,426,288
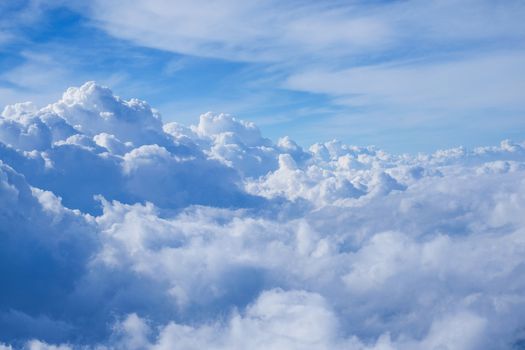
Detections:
285,52,525,112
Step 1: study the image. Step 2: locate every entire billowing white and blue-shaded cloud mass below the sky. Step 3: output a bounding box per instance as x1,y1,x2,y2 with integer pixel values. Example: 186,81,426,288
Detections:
0,83,525,349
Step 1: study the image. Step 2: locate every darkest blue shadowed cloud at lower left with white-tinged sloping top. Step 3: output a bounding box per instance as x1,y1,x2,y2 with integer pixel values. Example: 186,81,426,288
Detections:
0,164,97,340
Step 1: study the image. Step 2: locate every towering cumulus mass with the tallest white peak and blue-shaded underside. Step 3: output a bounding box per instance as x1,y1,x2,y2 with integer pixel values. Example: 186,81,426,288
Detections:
0,82,258,213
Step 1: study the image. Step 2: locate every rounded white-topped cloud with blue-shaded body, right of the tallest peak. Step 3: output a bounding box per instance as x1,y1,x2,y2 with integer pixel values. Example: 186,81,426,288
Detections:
121,145,257,208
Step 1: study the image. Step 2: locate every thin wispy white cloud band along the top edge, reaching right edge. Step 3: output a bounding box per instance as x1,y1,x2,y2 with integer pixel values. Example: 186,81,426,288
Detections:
84,0,524,62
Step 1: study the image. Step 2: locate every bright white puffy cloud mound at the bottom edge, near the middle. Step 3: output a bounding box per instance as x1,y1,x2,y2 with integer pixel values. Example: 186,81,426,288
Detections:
110,290,337,349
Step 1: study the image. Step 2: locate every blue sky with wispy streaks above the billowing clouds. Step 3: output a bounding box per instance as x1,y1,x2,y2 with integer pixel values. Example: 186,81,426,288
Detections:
0,0,525,153
